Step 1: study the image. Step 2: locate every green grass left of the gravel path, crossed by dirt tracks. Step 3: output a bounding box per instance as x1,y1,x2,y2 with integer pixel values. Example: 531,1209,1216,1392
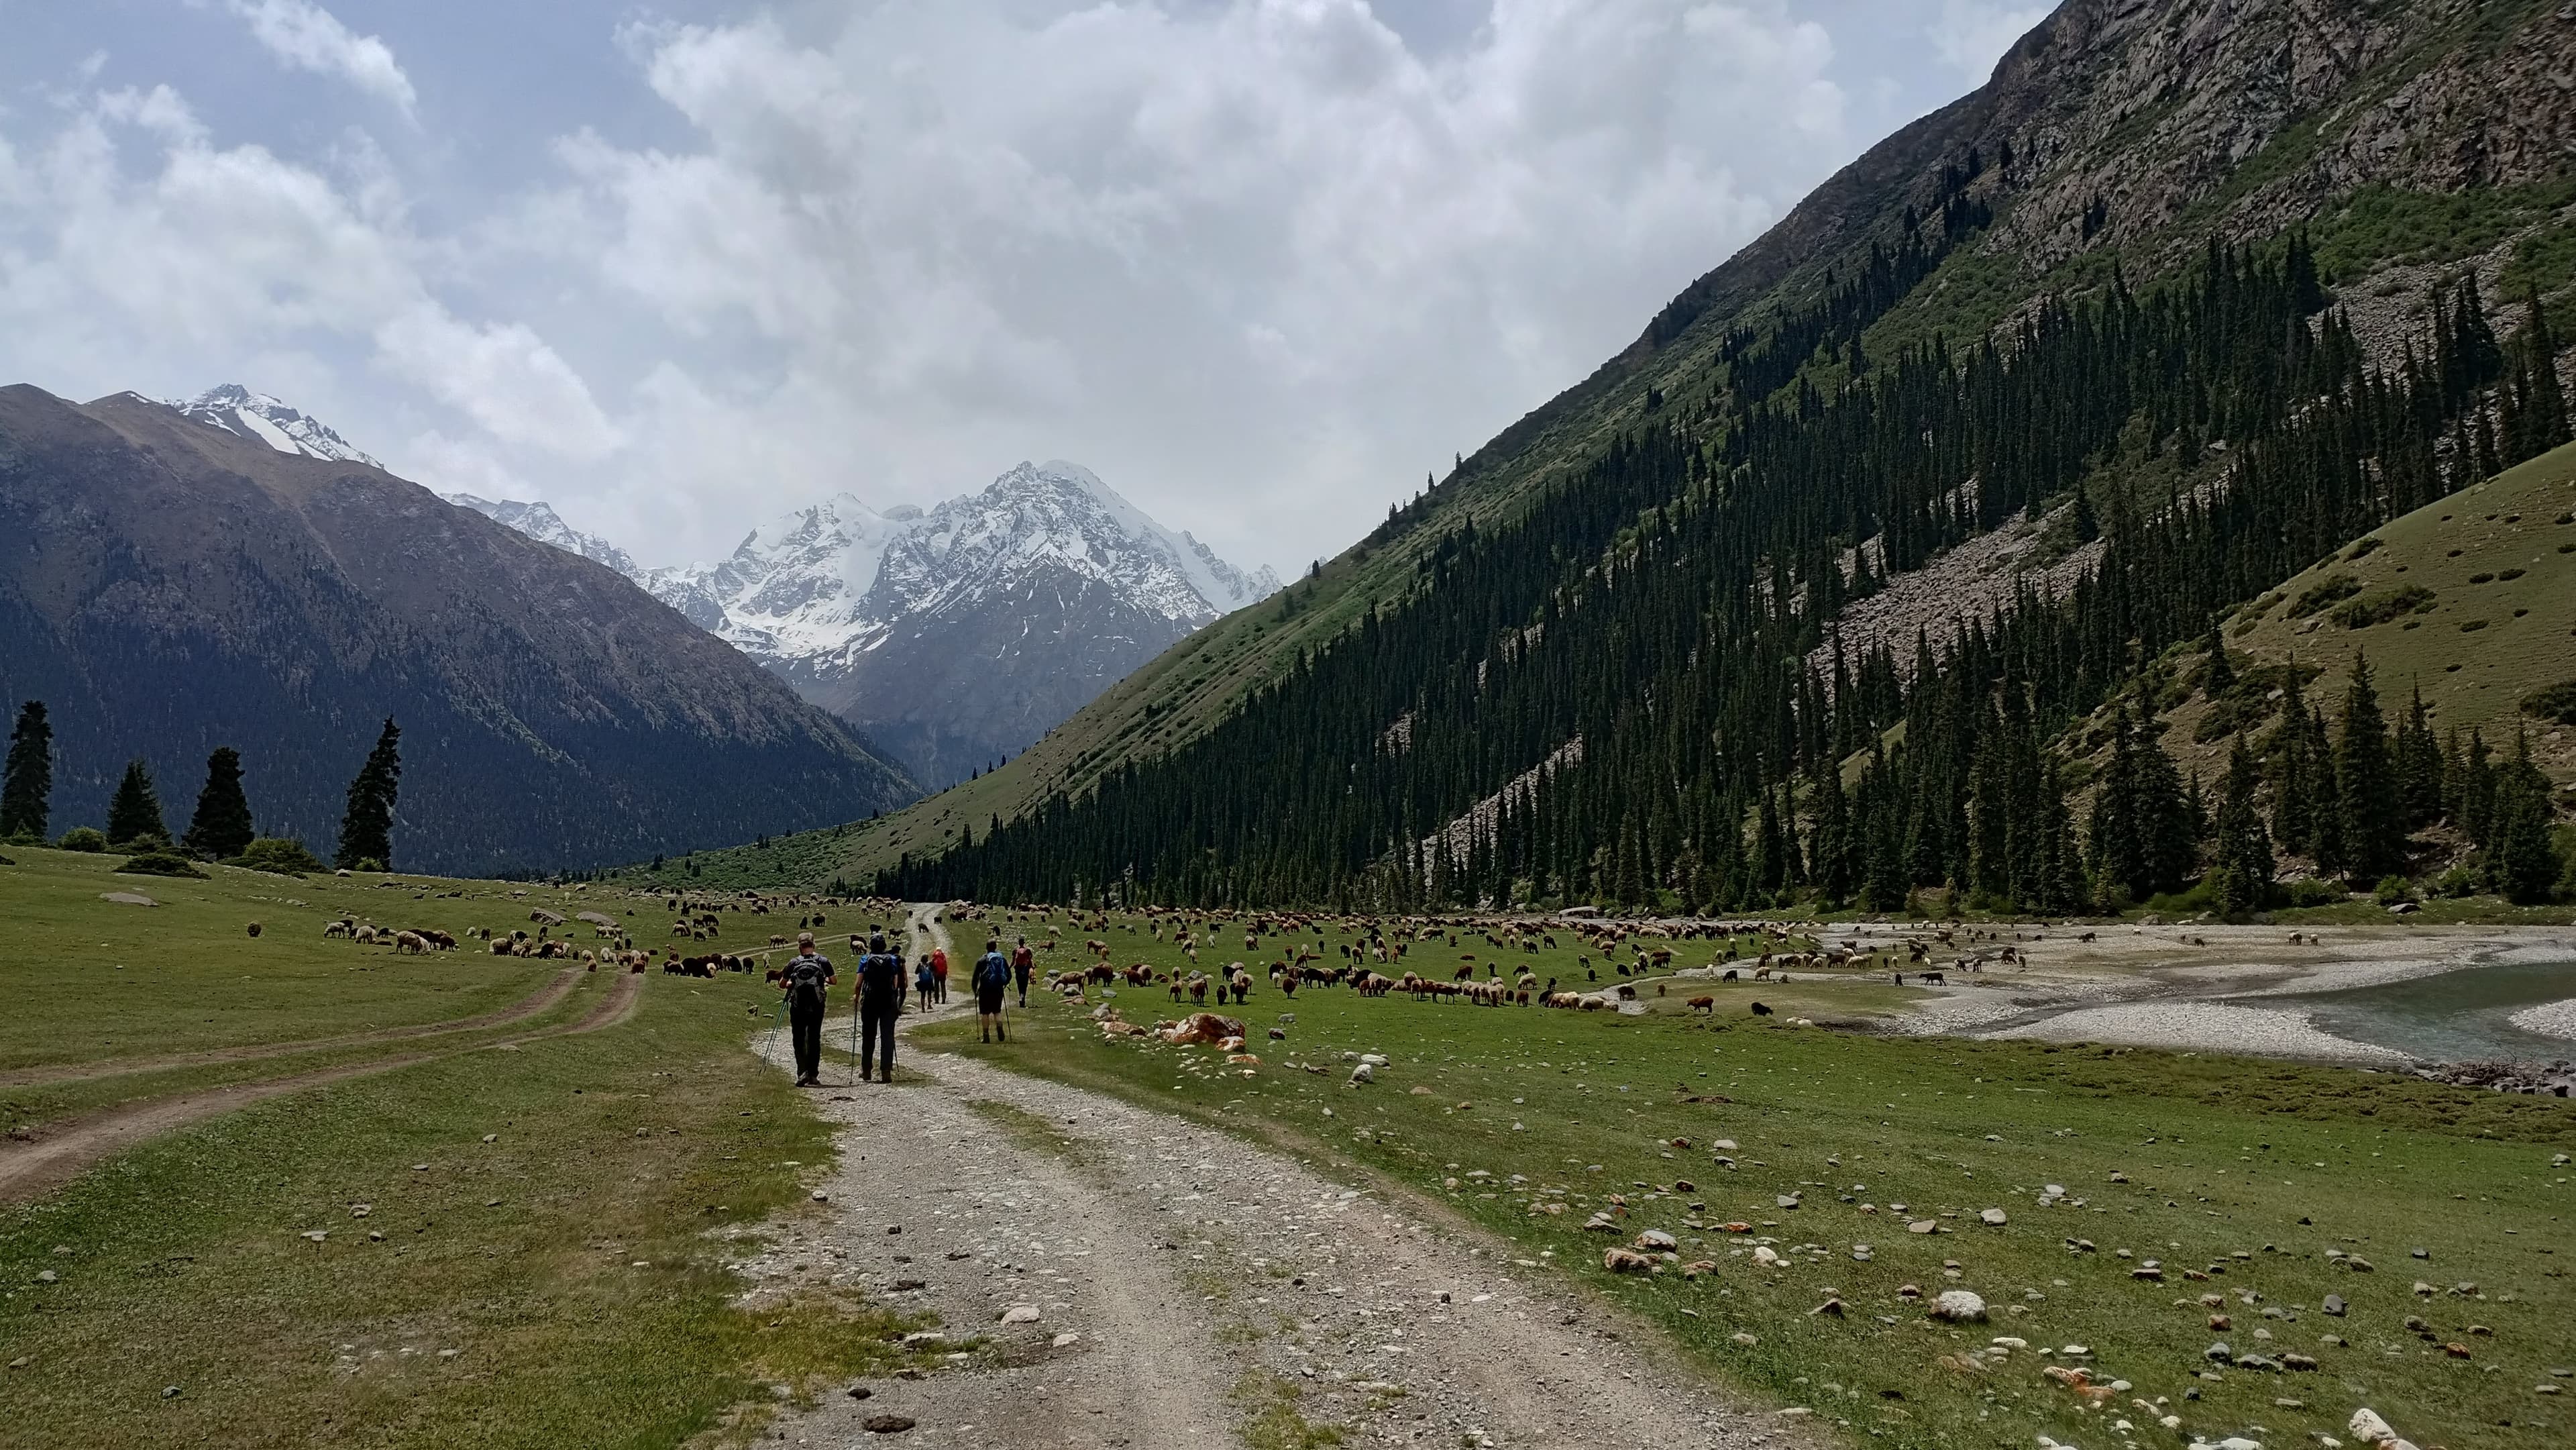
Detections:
0,850,927,1447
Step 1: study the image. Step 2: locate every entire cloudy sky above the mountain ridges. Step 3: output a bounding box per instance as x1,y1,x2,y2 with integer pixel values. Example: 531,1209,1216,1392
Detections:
0,0,2045,574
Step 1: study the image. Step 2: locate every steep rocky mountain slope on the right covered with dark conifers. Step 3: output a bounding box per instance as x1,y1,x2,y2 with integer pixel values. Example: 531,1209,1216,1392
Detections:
680,0,2576,896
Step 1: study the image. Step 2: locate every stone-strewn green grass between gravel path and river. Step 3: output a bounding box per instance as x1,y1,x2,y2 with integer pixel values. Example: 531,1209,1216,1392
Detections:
925,907,2576,1450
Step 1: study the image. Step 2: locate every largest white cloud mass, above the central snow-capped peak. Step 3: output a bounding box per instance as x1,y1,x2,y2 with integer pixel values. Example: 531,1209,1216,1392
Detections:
538,0,1852,566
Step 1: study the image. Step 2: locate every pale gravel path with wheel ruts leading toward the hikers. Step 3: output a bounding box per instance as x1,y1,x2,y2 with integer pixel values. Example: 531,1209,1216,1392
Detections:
737,915,1785,1450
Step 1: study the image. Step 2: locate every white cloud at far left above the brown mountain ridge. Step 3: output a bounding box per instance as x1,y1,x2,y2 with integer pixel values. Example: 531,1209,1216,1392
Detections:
0,88,619,461
